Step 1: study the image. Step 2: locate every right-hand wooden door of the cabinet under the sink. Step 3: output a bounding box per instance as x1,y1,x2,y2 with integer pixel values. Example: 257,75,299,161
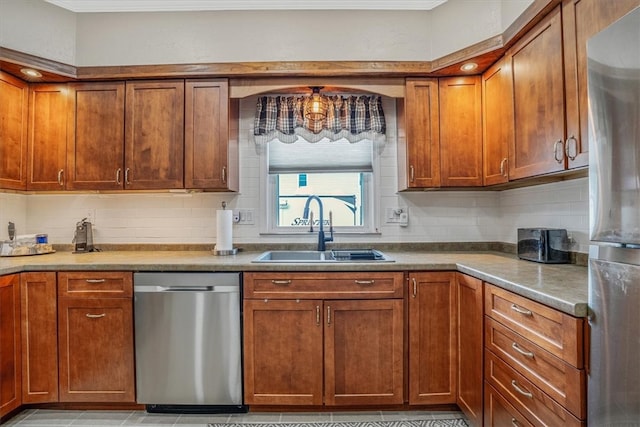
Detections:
324,299,404,405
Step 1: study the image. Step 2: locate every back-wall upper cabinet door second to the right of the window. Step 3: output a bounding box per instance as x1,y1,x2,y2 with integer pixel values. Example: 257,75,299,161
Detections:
438,76,482,187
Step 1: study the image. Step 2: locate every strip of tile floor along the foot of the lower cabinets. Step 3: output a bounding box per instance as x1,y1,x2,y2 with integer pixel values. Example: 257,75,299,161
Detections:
2,409,464,427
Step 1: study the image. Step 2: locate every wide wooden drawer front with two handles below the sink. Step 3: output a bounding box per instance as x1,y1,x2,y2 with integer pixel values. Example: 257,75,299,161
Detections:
244,272,404,299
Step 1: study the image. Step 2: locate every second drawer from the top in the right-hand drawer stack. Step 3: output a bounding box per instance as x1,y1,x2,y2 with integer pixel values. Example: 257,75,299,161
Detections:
485,317,586,418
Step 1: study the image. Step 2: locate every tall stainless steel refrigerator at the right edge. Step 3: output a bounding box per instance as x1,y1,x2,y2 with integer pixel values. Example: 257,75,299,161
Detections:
587,7,640,427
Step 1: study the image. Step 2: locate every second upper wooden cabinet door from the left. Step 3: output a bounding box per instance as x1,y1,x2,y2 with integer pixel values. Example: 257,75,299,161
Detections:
27,84,69,190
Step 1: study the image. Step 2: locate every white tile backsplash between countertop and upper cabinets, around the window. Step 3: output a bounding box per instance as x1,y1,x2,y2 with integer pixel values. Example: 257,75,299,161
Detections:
0,97,589,252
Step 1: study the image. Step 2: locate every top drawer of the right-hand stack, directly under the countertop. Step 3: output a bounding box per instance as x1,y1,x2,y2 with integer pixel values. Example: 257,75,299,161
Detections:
485,285,584,369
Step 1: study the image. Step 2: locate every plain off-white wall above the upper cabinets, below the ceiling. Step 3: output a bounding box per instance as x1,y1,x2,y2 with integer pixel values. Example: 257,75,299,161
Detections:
0,0,533,66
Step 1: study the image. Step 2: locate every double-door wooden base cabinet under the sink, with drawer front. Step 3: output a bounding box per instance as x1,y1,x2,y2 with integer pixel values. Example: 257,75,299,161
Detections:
244,272,404,406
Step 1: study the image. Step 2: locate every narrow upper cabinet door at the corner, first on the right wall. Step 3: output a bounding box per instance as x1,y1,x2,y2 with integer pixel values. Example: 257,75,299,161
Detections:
482,58,514,185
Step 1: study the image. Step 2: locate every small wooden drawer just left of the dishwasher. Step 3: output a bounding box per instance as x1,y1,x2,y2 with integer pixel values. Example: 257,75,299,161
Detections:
58,271,133,298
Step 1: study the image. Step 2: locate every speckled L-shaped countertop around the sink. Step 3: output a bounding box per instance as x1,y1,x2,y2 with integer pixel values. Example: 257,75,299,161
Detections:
0,250,587,317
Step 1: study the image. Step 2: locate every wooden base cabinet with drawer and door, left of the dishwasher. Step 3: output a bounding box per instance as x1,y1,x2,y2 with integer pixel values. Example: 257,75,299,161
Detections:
58,272,135,402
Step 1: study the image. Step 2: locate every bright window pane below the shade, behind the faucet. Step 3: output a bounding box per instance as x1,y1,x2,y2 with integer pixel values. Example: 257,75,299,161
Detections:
276,172,365,228
